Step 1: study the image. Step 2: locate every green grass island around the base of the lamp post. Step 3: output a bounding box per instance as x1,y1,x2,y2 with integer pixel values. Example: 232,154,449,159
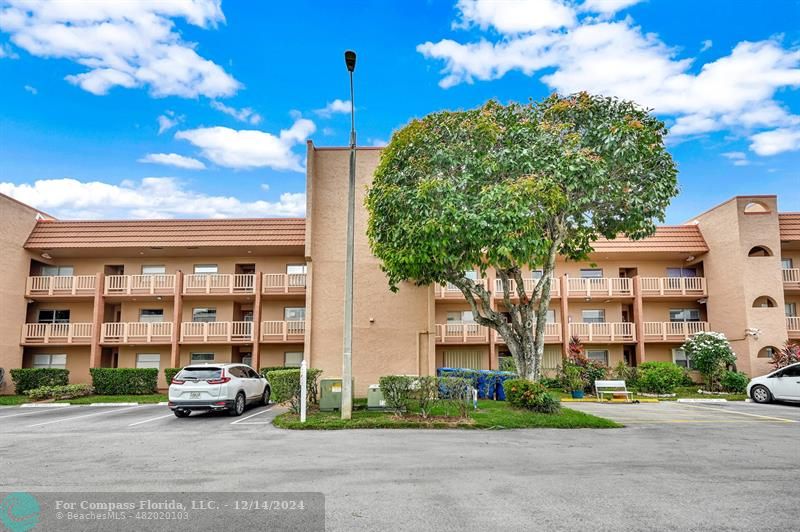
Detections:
273,400,622,430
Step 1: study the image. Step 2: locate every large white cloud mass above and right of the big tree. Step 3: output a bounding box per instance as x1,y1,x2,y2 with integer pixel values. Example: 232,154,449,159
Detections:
417,0,800,155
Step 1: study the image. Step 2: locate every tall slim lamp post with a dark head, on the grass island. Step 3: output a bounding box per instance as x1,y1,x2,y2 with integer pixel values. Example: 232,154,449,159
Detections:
342,50,356,419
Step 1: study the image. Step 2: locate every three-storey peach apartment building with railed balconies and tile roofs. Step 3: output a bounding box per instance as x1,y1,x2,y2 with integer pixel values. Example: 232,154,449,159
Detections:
0,142,800,395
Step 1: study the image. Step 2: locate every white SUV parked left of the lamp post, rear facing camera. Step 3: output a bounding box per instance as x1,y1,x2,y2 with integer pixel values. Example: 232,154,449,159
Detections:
169,364,270,417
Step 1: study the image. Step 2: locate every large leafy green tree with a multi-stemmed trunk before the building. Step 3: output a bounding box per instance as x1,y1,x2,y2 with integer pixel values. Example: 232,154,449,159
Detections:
366,93,677,380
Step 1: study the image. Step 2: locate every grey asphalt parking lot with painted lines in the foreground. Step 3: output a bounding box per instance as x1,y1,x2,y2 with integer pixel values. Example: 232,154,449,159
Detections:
0,402,800,531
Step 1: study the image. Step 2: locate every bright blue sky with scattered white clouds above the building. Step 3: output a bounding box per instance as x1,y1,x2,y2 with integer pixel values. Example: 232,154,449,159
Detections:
0,0,800,223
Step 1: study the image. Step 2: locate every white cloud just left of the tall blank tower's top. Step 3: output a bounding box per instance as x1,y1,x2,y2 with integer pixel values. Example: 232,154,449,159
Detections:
175,118,316,172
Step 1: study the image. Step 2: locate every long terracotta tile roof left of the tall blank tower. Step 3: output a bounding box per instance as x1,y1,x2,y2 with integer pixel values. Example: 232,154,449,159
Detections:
25,218,306,249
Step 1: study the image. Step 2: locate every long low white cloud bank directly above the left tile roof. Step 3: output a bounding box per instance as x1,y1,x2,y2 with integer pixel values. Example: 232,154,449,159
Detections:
0,177,306,219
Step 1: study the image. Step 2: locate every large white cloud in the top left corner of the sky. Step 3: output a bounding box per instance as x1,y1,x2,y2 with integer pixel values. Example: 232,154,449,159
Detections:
0,0,240,98
